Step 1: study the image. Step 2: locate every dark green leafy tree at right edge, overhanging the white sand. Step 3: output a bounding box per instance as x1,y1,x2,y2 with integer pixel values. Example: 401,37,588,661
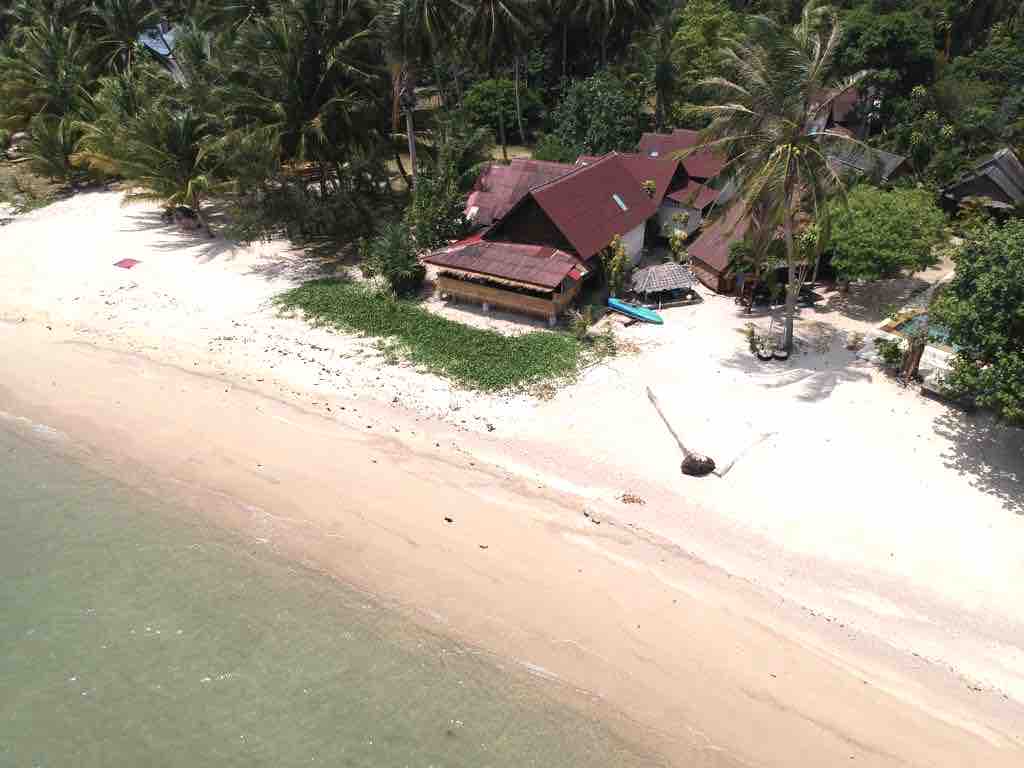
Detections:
931,220,1024,426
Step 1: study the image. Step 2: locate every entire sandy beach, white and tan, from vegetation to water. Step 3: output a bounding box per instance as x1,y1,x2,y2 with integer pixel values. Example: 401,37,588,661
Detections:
0,193,1024,766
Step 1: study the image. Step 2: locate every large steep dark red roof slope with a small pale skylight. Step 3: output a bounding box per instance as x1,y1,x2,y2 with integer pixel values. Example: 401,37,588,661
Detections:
529,154,657,259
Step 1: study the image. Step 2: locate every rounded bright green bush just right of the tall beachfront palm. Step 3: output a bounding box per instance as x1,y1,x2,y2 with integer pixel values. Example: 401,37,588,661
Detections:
828,184,946,281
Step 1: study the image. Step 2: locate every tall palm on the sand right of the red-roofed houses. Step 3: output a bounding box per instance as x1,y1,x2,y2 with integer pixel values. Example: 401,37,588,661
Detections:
684,0,866,350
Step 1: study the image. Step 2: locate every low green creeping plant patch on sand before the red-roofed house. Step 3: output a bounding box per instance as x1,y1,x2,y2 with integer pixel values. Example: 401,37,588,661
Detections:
275,280,615,392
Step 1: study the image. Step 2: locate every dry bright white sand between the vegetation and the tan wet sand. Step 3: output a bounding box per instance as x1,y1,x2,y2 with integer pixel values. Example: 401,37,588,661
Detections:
0,193,1024,761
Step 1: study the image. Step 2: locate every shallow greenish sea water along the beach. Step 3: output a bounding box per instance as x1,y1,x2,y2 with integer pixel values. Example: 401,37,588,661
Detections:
0,422,650,768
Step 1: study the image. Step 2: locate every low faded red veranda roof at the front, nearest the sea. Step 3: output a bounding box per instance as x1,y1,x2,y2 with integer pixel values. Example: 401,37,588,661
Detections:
423,238,581,290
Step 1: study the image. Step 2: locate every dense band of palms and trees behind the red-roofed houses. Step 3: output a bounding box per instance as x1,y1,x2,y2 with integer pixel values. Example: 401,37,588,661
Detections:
0,0,1024,409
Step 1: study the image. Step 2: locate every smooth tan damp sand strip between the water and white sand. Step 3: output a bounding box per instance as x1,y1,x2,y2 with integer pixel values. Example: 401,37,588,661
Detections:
0,323,1022,766
